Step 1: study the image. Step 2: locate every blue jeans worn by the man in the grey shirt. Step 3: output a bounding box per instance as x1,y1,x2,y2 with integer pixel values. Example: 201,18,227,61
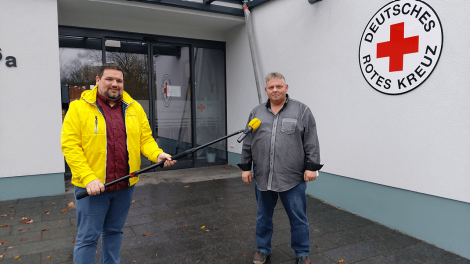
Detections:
255,182,310,257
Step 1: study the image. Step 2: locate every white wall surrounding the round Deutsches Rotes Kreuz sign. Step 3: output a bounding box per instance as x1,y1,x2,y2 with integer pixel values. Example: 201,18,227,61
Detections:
226,0,470,203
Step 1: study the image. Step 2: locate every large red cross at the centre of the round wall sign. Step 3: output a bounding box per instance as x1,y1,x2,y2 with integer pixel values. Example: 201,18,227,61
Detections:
377,22,419,72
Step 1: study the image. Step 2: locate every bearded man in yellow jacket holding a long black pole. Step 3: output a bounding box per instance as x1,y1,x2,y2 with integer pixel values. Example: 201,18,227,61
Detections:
61,63,176,264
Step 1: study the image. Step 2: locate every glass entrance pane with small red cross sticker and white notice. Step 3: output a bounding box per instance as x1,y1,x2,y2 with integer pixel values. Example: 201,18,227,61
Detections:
152,44,193,168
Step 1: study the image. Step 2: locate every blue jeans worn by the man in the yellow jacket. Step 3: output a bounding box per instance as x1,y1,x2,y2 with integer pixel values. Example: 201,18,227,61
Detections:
73,186,134,264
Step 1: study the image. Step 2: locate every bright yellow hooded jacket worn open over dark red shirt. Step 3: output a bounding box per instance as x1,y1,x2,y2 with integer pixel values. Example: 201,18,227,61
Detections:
61,86,163,188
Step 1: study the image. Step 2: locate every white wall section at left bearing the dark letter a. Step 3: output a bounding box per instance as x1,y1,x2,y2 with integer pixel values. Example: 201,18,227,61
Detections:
0,0,64,177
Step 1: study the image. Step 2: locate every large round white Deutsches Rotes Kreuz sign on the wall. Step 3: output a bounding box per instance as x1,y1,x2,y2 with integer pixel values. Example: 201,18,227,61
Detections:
359,0,444,95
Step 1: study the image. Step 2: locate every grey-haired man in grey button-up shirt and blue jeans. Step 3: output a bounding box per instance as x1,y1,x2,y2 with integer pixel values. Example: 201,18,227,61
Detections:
238,72,323,264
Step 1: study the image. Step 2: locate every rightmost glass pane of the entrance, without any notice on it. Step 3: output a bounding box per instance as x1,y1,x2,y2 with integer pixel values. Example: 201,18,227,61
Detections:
194,48,227,166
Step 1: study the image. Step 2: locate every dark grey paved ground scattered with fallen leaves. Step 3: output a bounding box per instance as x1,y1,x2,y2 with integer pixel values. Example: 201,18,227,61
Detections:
0,166,470,264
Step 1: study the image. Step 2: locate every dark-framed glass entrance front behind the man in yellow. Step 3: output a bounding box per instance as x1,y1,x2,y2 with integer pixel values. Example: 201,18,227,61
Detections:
59,27,227,170
